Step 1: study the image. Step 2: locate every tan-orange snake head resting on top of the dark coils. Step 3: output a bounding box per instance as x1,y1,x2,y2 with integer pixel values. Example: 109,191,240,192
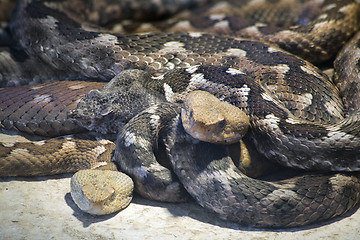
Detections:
181,91,249,144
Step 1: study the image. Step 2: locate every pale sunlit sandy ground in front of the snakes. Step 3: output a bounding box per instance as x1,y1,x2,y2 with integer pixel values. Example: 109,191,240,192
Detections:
0,174,360,240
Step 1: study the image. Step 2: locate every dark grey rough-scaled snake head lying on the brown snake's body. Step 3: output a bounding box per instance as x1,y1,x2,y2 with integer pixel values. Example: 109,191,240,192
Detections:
70,70,164,134
